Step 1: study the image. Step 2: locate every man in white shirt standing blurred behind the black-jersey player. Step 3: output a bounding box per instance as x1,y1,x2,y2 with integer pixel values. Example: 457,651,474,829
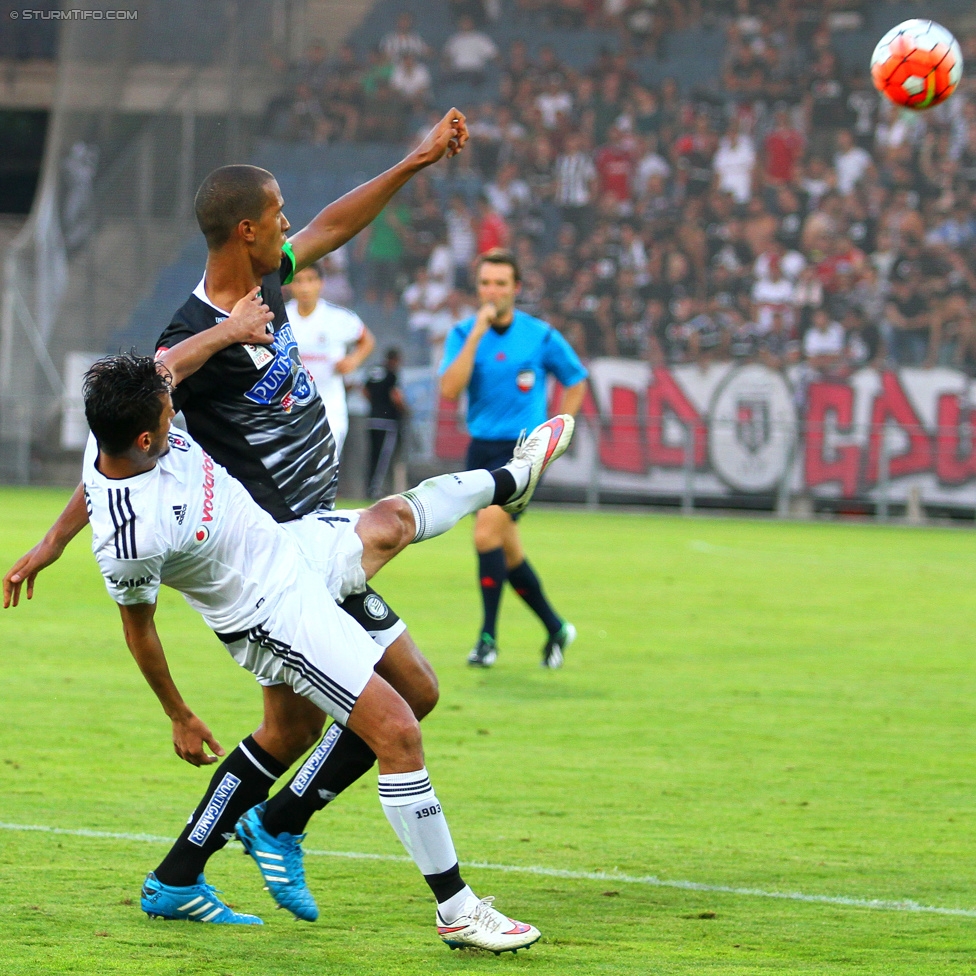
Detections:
285,264,376,457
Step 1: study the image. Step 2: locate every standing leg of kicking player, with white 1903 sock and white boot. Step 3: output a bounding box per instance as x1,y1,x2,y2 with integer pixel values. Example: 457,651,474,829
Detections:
348,675,540,955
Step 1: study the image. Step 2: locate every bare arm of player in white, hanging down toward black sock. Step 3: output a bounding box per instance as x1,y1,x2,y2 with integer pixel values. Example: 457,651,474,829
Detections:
119,603,224,766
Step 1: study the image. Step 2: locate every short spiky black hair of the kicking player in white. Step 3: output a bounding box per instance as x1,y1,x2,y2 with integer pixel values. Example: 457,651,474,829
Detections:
83,353,171,457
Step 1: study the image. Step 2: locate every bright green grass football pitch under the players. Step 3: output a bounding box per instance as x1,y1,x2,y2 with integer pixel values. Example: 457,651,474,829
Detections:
0,489,976,976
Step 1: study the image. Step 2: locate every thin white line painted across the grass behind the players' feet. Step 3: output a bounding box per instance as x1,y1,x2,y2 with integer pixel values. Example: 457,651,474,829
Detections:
0,822,976,918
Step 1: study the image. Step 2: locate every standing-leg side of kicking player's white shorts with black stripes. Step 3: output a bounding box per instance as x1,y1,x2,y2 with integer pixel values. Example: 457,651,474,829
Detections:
222,573,384,724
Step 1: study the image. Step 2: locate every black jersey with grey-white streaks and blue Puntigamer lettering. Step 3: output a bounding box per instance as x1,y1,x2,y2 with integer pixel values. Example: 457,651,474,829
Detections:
156,250,338,522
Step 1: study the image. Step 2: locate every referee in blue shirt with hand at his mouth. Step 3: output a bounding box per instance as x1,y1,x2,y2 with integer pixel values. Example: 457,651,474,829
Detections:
440,249,587,668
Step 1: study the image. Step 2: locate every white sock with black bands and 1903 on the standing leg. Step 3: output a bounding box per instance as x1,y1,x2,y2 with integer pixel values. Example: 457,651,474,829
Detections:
379,768,457,876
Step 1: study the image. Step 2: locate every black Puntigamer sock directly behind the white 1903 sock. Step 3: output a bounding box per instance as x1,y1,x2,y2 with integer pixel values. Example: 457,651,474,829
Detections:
264,722,376,837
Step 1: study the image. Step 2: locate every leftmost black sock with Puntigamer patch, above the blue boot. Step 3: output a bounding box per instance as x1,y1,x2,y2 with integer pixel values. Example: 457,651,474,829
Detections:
155,736,288,887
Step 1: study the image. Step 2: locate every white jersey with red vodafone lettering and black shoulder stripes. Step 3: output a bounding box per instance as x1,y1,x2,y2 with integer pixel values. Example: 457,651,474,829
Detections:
83,429,305,634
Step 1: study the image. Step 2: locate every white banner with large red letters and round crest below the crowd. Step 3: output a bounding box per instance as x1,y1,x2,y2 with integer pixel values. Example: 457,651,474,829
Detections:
435,359,976,508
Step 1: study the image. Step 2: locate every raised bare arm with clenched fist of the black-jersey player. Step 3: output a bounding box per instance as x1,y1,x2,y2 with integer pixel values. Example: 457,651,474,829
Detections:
290,108,468,271
